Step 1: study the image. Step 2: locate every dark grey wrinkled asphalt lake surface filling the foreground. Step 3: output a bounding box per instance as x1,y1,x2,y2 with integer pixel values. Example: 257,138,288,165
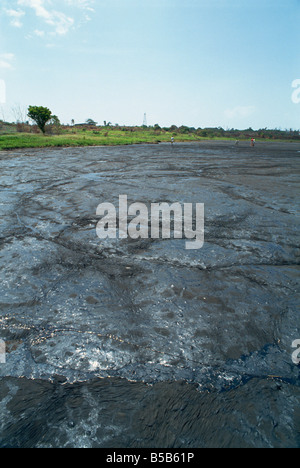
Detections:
0,142,300,448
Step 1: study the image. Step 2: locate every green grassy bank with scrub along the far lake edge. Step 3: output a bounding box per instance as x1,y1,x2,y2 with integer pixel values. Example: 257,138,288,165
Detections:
0,123,300,150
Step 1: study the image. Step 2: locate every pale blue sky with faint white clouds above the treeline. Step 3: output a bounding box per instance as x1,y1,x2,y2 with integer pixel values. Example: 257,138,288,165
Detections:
0,0,300,129
